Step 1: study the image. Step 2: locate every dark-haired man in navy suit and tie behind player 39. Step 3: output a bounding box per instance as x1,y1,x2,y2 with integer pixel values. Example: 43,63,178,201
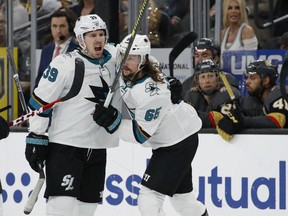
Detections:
34,8,78,88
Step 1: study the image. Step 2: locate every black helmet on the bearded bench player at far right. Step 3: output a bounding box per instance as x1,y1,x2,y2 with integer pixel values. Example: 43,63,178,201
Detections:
246,60,279,85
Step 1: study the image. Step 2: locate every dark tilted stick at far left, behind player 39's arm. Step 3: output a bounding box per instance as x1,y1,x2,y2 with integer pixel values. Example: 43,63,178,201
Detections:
7,47,28,114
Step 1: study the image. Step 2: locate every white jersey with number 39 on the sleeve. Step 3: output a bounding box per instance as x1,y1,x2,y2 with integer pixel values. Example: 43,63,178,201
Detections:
29,45,121,149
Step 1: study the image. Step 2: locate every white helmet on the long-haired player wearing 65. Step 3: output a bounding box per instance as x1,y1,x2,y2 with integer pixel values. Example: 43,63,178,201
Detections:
117,34,151,67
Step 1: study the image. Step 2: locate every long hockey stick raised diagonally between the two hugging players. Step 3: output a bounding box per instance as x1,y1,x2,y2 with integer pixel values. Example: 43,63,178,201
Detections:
104,0,149,107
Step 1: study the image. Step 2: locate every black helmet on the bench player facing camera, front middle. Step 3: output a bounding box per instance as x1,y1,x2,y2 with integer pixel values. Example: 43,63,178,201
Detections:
194,59,220,95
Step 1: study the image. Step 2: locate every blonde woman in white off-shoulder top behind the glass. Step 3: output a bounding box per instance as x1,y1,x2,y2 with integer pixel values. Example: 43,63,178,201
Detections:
221,0,258,60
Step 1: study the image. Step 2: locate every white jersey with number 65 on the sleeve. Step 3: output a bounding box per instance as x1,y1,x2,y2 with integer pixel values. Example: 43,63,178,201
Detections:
118,76,202,149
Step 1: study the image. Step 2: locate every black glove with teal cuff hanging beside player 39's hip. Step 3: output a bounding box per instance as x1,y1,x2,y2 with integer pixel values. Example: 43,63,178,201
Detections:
25,132,49,172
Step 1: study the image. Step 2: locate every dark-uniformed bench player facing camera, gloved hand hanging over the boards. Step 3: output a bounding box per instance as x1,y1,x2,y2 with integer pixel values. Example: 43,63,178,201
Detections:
184,59,241,141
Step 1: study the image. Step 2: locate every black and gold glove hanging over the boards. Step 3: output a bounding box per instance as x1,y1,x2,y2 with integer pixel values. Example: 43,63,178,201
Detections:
216,109,244,141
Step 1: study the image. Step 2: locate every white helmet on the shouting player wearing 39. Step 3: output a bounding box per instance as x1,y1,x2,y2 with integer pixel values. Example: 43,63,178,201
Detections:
74,14,109,49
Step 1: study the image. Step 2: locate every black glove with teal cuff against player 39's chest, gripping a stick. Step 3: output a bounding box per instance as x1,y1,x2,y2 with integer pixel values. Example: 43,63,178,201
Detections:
93,102,122,134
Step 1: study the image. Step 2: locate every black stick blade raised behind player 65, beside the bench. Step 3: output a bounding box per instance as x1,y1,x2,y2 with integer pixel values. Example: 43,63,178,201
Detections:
169,32,198,77
